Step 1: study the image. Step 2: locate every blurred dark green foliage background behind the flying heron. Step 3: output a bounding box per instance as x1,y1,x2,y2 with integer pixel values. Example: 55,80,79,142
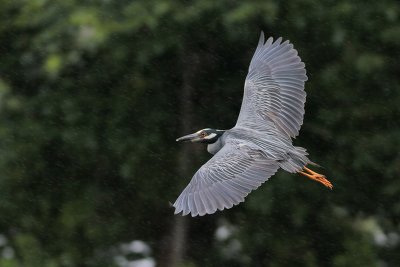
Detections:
0,0,400,267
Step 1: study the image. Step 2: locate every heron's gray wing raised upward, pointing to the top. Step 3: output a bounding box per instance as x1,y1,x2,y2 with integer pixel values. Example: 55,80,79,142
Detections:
236,32,307,138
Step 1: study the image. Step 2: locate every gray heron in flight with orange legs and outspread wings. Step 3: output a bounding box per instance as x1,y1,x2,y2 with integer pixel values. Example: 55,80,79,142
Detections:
173,32,333,219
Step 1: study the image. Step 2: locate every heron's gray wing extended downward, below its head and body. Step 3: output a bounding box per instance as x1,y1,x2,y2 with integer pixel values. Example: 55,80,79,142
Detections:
174,143,278,216
